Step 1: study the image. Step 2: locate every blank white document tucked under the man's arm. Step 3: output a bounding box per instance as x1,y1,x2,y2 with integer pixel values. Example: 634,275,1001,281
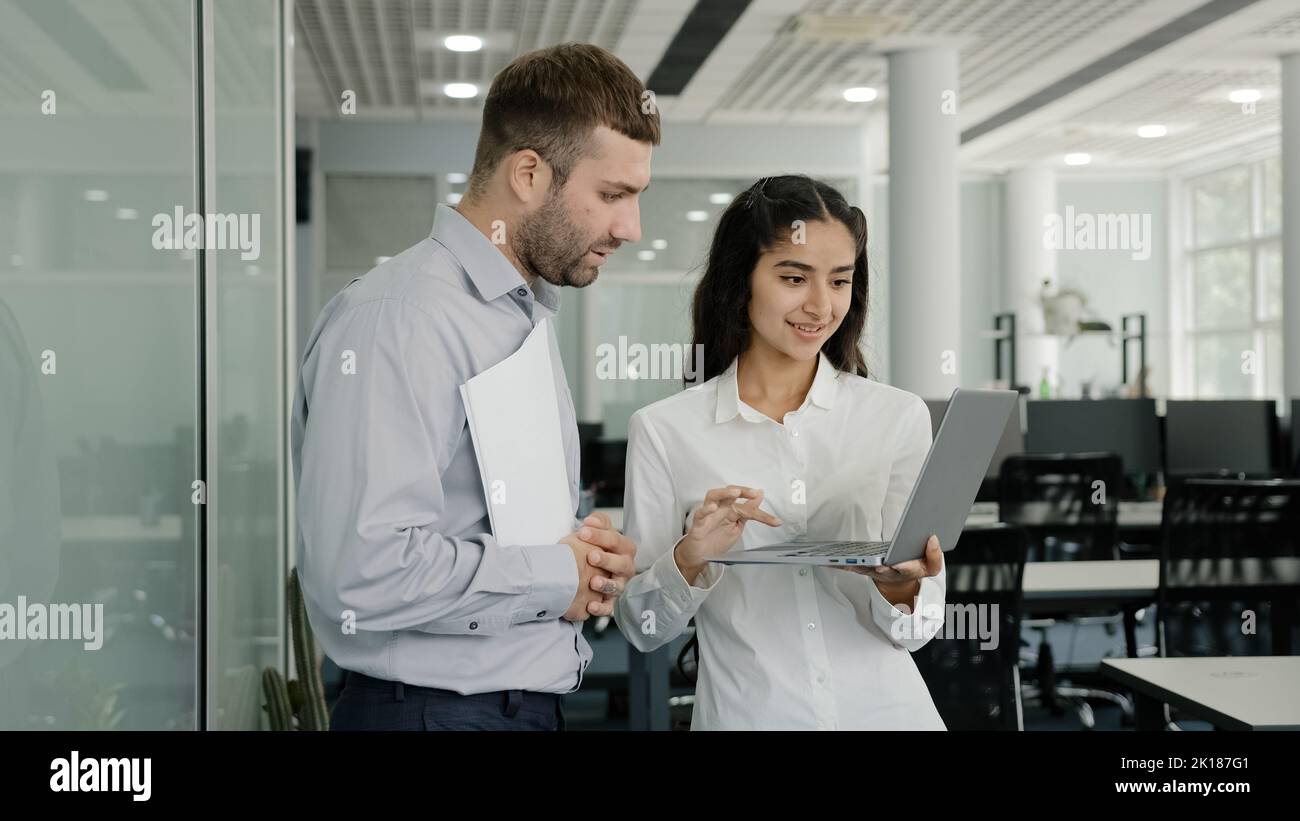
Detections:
460,318,573,544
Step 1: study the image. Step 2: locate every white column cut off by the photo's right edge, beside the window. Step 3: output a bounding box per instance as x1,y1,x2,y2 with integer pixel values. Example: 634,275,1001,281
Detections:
1282,53,1300,399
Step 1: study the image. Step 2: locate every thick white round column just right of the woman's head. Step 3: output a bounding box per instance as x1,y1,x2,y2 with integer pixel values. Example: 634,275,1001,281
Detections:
889,48,961,399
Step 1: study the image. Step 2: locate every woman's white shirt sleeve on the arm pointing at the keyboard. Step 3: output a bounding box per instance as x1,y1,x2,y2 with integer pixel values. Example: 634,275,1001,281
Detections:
615,412,725,652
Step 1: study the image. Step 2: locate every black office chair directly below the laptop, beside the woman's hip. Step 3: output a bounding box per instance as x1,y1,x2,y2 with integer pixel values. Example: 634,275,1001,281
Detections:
911,524,1028,730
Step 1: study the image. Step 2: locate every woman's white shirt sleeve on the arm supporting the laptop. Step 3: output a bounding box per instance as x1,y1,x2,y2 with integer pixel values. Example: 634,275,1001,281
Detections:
868,398,948,651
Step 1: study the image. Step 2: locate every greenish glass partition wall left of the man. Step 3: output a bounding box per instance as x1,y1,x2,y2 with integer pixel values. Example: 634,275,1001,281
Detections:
0,0,291,730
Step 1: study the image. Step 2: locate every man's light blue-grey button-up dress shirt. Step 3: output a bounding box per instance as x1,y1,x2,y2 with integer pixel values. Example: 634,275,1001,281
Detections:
293,205,592,694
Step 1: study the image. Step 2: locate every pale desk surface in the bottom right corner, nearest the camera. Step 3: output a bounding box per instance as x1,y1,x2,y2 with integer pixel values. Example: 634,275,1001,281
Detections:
1101,656,1300,730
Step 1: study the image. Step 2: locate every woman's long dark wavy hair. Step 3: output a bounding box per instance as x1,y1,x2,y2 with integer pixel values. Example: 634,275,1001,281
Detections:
692,174,867,382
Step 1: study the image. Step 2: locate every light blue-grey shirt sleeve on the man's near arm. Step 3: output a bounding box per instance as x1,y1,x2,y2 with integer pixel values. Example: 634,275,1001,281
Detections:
295,299,579,635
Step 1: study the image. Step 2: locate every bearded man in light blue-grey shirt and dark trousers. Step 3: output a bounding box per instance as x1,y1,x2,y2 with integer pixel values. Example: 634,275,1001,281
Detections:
294,44,659,729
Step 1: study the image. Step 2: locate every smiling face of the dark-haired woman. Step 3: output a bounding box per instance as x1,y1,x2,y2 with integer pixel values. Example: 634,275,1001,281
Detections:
749,220,857,361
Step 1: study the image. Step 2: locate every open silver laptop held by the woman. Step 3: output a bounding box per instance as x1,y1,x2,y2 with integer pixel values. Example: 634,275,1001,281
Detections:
711,388,1018,565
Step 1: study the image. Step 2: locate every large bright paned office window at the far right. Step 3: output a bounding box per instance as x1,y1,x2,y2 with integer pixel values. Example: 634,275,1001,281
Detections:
1186,157,1282,399
